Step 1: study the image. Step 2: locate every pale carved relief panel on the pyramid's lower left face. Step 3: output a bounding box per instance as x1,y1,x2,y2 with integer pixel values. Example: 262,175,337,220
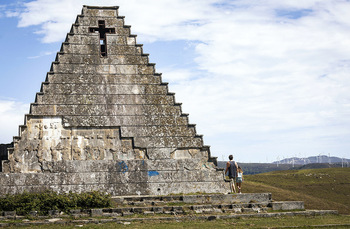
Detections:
9,117,147,172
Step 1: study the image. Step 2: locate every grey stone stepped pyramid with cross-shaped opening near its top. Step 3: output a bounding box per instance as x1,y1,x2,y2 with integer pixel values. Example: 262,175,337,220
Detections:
0,6,229,195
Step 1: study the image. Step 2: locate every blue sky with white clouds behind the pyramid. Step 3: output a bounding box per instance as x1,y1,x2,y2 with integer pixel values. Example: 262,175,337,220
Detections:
0,0,350,162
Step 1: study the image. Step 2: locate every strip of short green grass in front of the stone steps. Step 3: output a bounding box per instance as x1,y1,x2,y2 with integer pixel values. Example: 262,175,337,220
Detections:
1,215,350,229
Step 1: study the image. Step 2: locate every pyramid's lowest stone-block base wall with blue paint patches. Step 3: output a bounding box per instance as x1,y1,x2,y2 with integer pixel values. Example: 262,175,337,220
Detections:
0,159,229,196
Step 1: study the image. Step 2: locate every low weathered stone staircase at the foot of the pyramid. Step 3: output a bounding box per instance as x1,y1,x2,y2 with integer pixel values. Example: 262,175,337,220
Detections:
0,193,338,227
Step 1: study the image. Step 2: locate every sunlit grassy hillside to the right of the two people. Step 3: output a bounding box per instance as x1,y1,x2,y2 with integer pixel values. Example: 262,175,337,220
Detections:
242,168,350,215
